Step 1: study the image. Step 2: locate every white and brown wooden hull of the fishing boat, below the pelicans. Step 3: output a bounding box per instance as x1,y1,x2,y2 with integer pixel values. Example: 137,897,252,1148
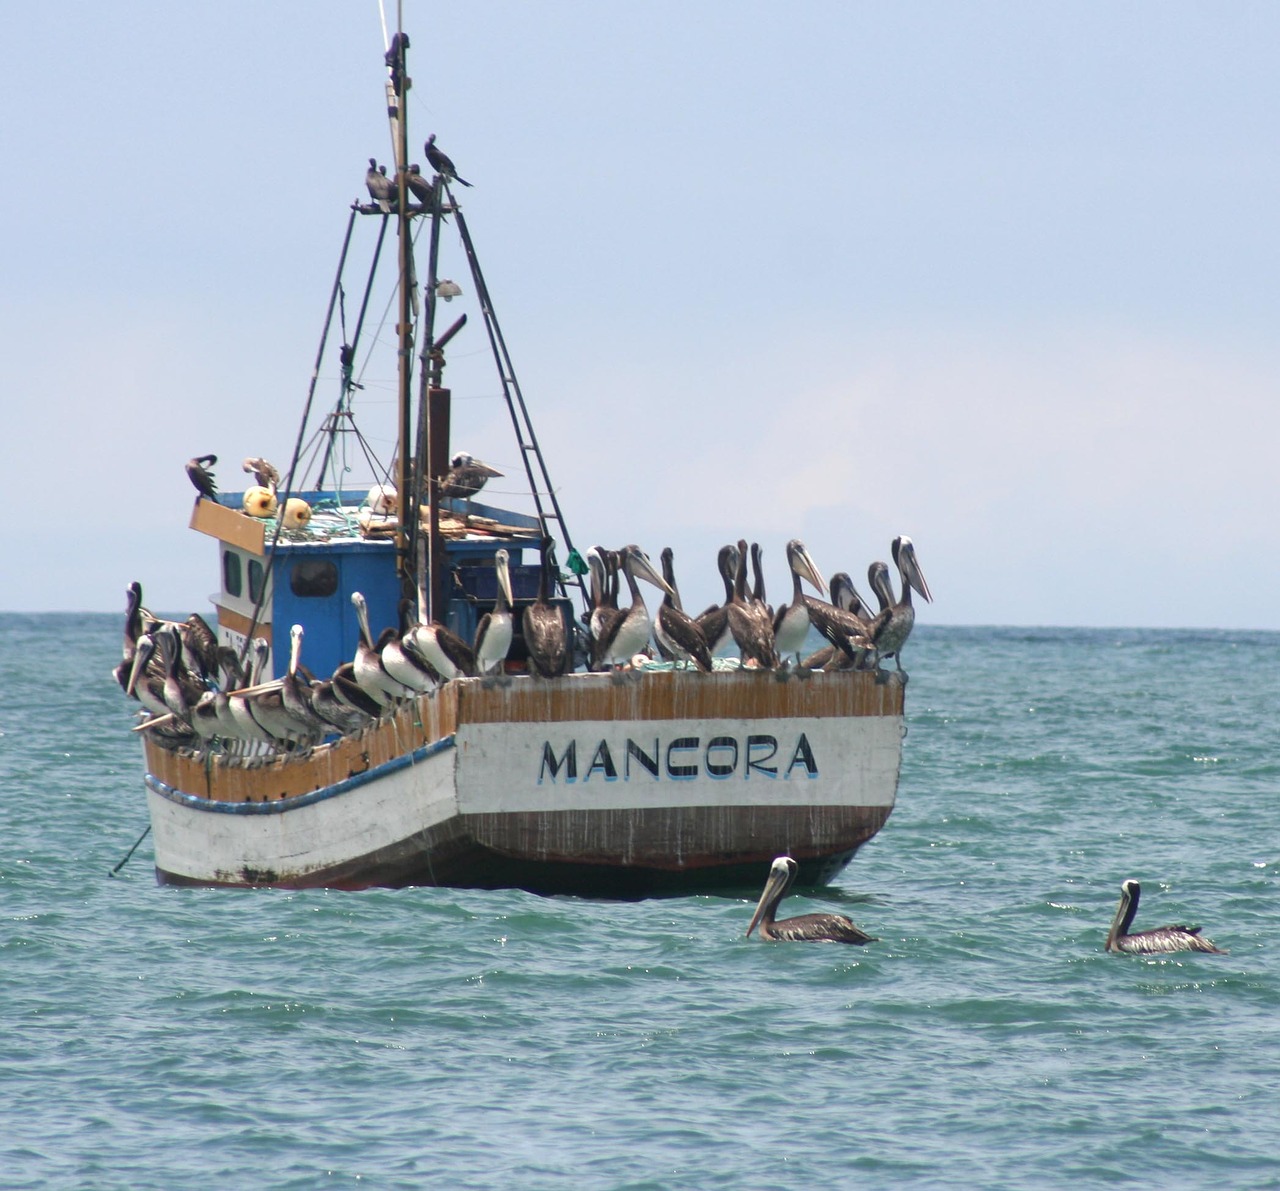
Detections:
146,671,902,896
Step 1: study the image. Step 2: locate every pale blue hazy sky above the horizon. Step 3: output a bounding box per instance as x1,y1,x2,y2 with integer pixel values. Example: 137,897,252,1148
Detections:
0,0,1280,629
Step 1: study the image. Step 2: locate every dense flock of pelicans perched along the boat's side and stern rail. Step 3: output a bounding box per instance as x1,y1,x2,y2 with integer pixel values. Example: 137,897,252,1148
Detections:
115,537,932,763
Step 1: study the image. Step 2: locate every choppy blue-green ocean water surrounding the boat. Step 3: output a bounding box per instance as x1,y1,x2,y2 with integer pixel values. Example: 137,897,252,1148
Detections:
0,615,1280,1188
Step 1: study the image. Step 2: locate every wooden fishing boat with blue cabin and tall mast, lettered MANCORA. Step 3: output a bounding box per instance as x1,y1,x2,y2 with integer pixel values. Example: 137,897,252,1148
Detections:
119,27,905,898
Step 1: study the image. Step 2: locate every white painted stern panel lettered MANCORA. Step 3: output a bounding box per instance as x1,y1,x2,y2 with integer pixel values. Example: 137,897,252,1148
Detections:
457,716,902,814
